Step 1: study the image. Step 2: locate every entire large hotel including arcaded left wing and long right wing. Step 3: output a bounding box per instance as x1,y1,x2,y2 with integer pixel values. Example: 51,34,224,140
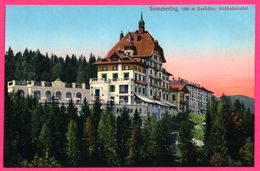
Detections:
8,14,212,119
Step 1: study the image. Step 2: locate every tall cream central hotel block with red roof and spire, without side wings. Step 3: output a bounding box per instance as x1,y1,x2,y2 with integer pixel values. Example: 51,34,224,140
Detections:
90,15,177,118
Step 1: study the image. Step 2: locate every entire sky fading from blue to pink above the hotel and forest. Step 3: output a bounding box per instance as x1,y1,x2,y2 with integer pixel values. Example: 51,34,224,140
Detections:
5,5,255,98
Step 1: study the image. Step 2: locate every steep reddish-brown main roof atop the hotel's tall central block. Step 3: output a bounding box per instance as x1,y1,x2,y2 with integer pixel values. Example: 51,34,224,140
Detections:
106,30,166,62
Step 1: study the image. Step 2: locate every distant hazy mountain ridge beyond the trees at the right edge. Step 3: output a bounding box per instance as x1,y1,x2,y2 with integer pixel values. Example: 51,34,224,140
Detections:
228,95,255,113
